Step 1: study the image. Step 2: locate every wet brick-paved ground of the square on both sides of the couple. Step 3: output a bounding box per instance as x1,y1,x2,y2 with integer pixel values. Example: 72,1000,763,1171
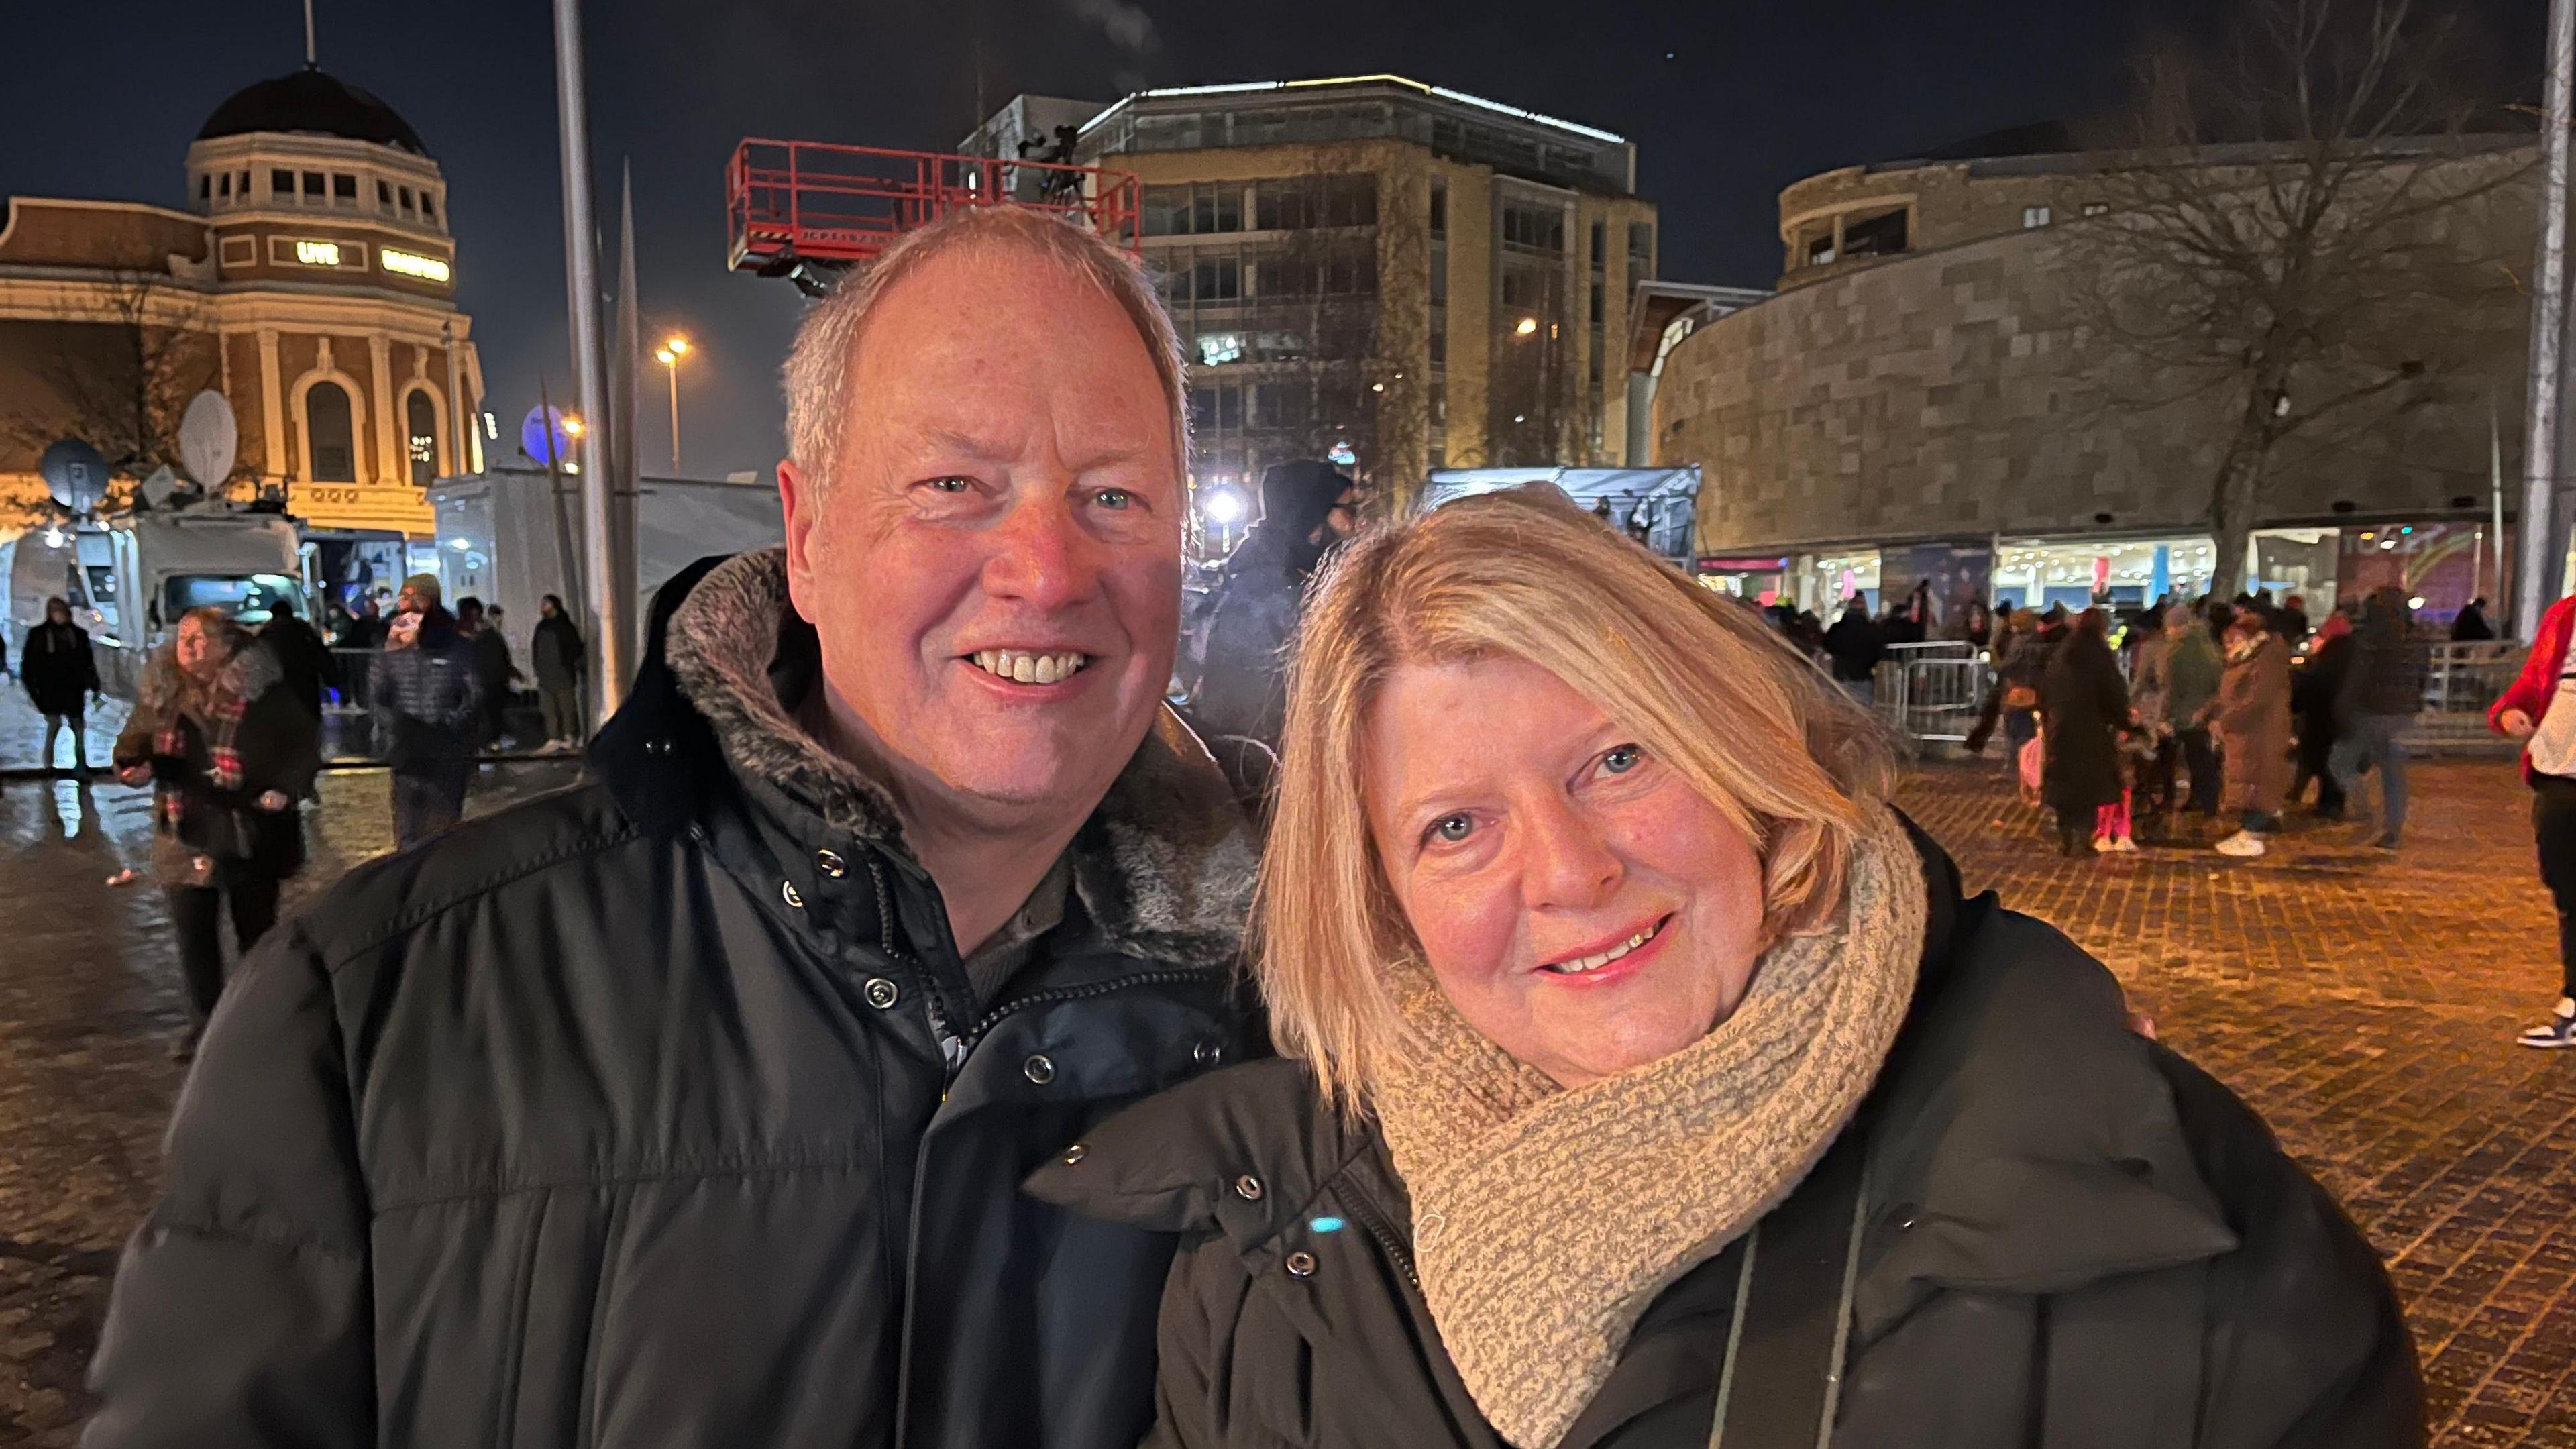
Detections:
0,675,2576,1449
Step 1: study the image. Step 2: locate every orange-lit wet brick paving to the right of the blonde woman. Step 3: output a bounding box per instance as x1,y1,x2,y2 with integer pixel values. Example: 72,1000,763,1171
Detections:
1904,761,2576,1449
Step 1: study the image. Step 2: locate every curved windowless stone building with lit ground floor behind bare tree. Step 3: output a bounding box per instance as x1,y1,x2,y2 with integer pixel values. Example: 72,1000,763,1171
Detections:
1654,129,2535,616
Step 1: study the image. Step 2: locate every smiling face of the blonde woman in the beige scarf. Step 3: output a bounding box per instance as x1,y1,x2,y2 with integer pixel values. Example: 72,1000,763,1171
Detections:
1362,657,1762,1088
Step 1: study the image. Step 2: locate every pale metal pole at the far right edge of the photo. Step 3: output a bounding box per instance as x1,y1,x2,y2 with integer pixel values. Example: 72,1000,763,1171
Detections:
2514,0,2576,642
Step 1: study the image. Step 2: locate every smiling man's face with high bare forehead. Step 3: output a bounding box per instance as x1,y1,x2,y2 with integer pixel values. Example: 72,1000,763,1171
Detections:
778,245,1183,825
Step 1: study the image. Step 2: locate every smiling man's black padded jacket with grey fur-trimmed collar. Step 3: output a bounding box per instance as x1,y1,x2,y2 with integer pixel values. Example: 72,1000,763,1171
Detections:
85,551,1252,1449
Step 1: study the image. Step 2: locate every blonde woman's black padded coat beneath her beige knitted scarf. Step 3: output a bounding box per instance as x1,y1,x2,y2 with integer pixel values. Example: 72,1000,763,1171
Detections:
1030,824,2424,1449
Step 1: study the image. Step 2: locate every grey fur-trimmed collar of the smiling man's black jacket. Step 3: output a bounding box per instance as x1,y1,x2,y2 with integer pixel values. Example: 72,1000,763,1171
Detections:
590,547,1257,967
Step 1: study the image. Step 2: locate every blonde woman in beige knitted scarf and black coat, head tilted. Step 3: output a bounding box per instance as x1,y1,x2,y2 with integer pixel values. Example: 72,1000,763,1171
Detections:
1030,492,2422,1449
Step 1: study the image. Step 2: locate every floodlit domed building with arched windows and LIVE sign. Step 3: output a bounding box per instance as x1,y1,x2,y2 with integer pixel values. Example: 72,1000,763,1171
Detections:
0,64,482,539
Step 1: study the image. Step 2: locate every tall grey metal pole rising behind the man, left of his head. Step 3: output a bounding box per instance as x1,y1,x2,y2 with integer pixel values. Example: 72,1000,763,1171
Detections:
554,0,631,719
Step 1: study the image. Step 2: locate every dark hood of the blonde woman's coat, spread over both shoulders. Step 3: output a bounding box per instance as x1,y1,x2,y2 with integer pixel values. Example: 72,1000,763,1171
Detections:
1028,822,2236,1341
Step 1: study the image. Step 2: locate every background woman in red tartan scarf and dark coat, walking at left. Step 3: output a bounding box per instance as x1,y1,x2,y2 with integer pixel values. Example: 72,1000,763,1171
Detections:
116,608,322,1057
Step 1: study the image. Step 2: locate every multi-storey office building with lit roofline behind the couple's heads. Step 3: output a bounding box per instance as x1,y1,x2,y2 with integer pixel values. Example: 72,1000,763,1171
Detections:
966,74,1656,536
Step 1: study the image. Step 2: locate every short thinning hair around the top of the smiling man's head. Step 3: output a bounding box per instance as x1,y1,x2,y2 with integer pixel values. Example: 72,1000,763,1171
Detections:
783,204,1190,487
